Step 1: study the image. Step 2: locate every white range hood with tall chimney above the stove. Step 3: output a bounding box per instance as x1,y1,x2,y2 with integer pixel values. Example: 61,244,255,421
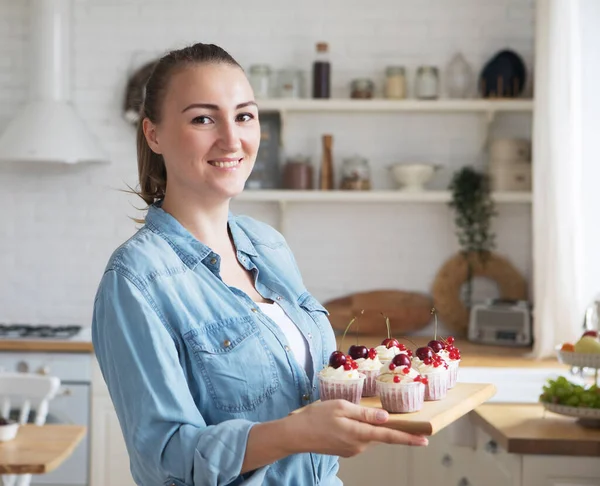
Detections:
0,0,108,164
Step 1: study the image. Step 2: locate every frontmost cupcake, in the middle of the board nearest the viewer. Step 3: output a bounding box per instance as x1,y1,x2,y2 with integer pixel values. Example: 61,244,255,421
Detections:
376,355,427,413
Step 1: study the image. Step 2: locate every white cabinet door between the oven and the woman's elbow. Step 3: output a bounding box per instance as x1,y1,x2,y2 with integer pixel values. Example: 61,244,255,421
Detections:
91,397,135,486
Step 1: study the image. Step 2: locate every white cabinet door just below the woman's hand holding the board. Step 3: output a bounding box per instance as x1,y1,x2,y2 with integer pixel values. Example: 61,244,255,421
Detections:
338,444,408,486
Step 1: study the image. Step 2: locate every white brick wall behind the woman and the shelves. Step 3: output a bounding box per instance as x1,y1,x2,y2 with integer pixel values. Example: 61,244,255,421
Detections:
0,0,534,334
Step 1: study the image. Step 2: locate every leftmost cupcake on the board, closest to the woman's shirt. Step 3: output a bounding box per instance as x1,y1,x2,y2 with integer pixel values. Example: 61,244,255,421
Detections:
318,351,365,404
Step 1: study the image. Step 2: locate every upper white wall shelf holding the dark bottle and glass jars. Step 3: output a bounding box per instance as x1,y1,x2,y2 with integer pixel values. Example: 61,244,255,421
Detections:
257,98,533,115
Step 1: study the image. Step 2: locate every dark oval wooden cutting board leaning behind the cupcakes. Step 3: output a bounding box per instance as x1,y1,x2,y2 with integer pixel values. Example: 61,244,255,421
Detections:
323,290,433,339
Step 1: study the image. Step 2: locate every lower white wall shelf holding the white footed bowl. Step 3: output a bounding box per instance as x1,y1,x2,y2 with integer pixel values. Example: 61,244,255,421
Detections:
236,189,532,204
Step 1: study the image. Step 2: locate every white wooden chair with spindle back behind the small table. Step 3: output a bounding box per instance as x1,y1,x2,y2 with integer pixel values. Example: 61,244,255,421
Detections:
0,372,60,486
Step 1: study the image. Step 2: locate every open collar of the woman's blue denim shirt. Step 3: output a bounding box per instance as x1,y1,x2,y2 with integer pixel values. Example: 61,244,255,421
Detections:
145,201,257,268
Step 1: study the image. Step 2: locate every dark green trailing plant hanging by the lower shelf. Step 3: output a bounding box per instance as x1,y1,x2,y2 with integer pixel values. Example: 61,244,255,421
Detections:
449,167,497,308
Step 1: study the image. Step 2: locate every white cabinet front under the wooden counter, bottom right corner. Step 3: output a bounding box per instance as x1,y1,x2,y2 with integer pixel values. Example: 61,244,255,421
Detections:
523,456,600,486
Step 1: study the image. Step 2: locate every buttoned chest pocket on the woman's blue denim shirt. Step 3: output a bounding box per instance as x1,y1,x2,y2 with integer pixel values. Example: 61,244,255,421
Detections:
184,316,279,412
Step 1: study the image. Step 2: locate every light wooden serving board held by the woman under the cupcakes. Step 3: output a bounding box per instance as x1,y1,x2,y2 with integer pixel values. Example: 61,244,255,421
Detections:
360,382,496,435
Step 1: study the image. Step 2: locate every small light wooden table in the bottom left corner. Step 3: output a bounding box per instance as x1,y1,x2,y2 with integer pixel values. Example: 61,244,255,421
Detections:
0,424,86,474
